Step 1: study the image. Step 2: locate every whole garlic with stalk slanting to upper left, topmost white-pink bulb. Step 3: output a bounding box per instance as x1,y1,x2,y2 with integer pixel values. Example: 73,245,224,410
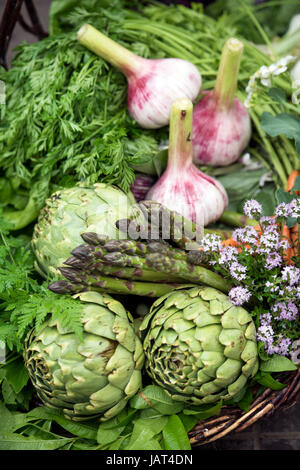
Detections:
77,24,202,129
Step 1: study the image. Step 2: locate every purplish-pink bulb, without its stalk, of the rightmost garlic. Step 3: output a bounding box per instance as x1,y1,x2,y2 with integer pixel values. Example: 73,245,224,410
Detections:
193,90,251,166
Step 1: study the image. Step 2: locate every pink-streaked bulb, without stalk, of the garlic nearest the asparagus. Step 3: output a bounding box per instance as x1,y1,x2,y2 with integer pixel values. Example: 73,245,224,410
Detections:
146,165,228,227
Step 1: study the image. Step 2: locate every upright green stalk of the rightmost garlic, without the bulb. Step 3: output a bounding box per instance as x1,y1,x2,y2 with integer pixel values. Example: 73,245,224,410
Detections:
215,38,244,108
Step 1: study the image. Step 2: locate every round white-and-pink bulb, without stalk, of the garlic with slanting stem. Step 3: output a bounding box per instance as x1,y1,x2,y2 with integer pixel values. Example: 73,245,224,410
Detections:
124,58,202,129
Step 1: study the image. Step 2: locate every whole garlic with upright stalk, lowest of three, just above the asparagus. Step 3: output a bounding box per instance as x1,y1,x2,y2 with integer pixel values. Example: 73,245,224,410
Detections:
146,98,228,227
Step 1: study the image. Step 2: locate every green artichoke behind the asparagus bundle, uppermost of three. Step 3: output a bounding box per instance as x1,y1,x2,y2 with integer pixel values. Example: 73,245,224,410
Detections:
32,183,139,277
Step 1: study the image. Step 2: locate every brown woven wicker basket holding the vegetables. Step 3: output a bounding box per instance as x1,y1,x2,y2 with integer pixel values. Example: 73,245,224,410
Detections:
0,0,300,446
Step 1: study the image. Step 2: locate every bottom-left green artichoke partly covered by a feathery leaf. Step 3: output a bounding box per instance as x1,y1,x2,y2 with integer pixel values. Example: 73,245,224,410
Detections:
24,292,144,421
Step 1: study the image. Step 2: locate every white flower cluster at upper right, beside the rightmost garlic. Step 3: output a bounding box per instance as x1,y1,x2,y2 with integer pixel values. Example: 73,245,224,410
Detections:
244,55,297,108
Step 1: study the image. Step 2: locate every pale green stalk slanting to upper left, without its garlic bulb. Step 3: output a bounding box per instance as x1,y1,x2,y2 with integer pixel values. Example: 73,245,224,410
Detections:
77,24,144,76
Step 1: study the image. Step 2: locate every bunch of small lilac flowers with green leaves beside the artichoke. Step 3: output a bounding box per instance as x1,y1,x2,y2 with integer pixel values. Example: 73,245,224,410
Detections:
201,197,300,356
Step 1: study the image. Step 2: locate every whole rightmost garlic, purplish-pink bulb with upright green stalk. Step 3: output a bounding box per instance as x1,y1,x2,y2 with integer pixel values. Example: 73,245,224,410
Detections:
193,38,251,166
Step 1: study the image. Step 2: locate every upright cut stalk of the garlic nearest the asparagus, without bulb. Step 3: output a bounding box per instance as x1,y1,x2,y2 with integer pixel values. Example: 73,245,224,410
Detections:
167,98,193,172
